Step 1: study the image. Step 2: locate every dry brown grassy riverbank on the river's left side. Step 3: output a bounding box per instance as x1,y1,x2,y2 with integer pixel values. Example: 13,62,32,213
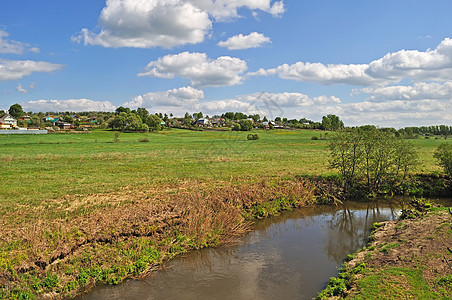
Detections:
0,179,315,299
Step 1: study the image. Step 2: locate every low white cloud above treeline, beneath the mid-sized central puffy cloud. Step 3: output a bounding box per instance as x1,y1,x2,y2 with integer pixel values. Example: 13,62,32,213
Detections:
123,87,204,109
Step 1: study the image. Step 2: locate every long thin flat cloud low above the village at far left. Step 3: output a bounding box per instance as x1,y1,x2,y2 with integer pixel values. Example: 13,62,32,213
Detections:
22,99,116,112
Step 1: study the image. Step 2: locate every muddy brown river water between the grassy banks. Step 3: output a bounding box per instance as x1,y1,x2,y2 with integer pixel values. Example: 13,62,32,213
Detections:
83,203,399,300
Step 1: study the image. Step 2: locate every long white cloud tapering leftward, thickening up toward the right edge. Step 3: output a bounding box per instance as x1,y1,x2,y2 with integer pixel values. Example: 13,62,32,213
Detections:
252,38,452,86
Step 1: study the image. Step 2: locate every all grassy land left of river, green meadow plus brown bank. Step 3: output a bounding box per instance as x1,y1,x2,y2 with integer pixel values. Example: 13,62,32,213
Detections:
0,129,450,298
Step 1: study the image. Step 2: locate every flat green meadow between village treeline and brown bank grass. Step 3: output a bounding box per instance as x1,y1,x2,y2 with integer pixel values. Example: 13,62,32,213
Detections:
0,130,444,204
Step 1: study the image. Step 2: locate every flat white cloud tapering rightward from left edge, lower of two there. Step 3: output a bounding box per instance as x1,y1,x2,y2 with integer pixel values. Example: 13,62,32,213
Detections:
0,59,63,81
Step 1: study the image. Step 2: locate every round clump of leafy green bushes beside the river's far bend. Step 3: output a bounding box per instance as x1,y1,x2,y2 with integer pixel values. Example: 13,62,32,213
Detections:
328,127,417,193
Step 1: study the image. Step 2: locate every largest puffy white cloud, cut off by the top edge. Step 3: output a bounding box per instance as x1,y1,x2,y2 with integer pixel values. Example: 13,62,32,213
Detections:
72,0,284,48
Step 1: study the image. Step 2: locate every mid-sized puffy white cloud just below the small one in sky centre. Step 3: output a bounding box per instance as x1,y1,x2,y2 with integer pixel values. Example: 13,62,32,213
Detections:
138,52,247,87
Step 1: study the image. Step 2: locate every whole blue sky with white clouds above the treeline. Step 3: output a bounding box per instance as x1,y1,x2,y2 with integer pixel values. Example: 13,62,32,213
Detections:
0,0,452,127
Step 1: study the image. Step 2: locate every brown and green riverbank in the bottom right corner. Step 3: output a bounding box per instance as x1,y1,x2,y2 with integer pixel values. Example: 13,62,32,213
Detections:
318,208,452,299
